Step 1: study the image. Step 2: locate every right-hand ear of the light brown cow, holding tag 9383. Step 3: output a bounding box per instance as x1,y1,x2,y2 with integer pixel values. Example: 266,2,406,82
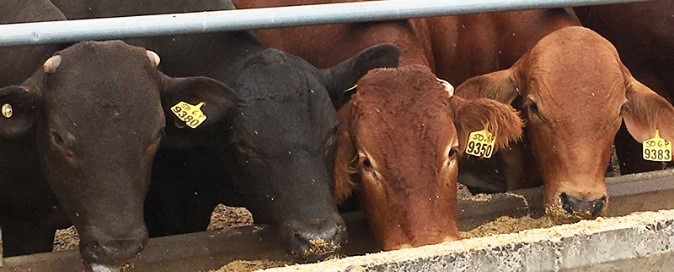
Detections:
621,76,674,143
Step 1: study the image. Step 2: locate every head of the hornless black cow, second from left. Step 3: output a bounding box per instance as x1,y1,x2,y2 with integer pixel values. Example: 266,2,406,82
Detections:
186,45,398,258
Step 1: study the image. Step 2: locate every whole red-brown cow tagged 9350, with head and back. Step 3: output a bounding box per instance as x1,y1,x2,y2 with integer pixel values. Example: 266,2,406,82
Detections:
235,0,522,250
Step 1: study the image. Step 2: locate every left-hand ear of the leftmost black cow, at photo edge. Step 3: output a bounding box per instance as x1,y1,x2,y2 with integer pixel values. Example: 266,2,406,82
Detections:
0,86,40,138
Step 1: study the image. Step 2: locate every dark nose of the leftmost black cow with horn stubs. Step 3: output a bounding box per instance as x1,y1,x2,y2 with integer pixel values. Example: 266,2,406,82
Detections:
80,227,148,266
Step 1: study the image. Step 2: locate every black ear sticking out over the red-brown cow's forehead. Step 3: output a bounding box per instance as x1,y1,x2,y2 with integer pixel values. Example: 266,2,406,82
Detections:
322,44,400,108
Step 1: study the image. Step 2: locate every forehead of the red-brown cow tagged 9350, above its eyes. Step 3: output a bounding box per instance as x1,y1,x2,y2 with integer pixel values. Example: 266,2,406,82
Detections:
352,67,456,163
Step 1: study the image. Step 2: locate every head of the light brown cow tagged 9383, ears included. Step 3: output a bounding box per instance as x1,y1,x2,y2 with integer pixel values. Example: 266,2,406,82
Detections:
457,27,674,222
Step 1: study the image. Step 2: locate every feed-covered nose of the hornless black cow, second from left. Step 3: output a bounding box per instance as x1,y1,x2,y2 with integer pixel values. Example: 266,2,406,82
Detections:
290,219,346,259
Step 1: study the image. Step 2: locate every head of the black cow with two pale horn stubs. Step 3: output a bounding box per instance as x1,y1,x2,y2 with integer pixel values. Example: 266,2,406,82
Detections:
0,41,232,267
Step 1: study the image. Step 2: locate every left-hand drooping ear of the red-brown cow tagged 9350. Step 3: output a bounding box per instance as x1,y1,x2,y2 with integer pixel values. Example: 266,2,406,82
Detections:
334,103,357,204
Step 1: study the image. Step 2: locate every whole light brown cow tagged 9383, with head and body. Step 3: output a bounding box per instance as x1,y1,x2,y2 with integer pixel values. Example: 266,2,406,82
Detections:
428,9,674,222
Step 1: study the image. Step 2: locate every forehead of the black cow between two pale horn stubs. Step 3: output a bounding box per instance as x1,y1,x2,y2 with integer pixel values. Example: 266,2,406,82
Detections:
43,42,162,133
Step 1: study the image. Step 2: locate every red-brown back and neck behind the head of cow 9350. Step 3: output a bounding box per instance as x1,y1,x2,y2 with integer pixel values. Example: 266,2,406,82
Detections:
233,0,433,68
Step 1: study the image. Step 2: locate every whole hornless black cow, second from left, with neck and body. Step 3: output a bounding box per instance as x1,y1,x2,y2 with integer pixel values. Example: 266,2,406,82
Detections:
54,0,399,258
